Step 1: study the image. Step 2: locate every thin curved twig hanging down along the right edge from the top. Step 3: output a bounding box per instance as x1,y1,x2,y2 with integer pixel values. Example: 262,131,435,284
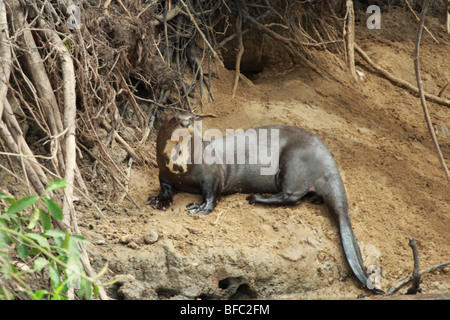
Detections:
414,0,450,184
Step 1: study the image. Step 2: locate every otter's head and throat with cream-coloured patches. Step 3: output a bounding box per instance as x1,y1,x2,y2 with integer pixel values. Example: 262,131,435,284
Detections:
156,113,197,173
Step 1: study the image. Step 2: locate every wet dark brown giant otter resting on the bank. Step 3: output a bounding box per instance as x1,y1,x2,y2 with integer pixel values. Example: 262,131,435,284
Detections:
149,114,384,294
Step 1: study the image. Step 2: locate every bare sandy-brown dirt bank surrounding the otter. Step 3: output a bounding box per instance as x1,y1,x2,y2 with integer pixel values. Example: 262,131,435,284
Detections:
77,12,450,299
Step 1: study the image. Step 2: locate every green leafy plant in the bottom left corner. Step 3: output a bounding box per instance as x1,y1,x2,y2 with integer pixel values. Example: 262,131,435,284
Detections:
0,179,110,300
